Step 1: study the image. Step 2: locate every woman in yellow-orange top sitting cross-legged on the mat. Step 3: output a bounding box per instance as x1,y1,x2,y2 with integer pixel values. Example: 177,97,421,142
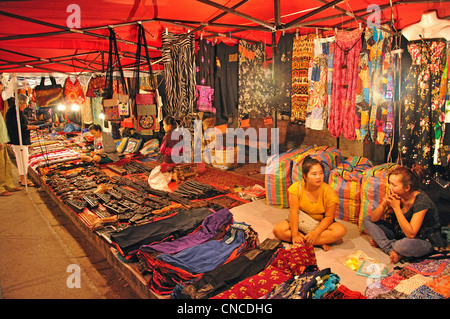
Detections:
273,156,346,251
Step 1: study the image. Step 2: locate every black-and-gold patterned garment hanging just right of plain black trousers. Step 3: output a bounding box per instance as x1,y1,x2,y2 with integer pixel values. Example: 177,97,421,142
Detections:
238,40,273,118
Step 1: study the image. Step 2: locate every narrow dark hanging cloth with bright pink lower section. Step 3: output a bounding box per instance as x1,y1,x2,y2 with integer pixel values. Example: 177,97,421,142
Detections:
195,39,216,113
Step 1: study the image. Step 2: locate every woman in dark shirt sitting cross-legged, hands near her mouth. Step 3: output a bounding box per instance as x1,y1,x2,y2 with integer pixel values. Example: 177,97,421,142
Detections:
363,165,440,263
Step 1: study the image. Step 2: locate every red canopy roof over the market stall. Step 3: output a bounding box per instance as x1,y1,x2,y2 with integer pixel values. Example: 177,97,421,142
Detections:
0,0,450,74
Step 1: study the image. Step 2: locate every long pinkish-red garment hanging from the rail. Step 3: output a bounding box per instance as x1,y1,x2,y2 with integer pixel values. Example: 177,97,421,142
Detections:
328,29,362,140
